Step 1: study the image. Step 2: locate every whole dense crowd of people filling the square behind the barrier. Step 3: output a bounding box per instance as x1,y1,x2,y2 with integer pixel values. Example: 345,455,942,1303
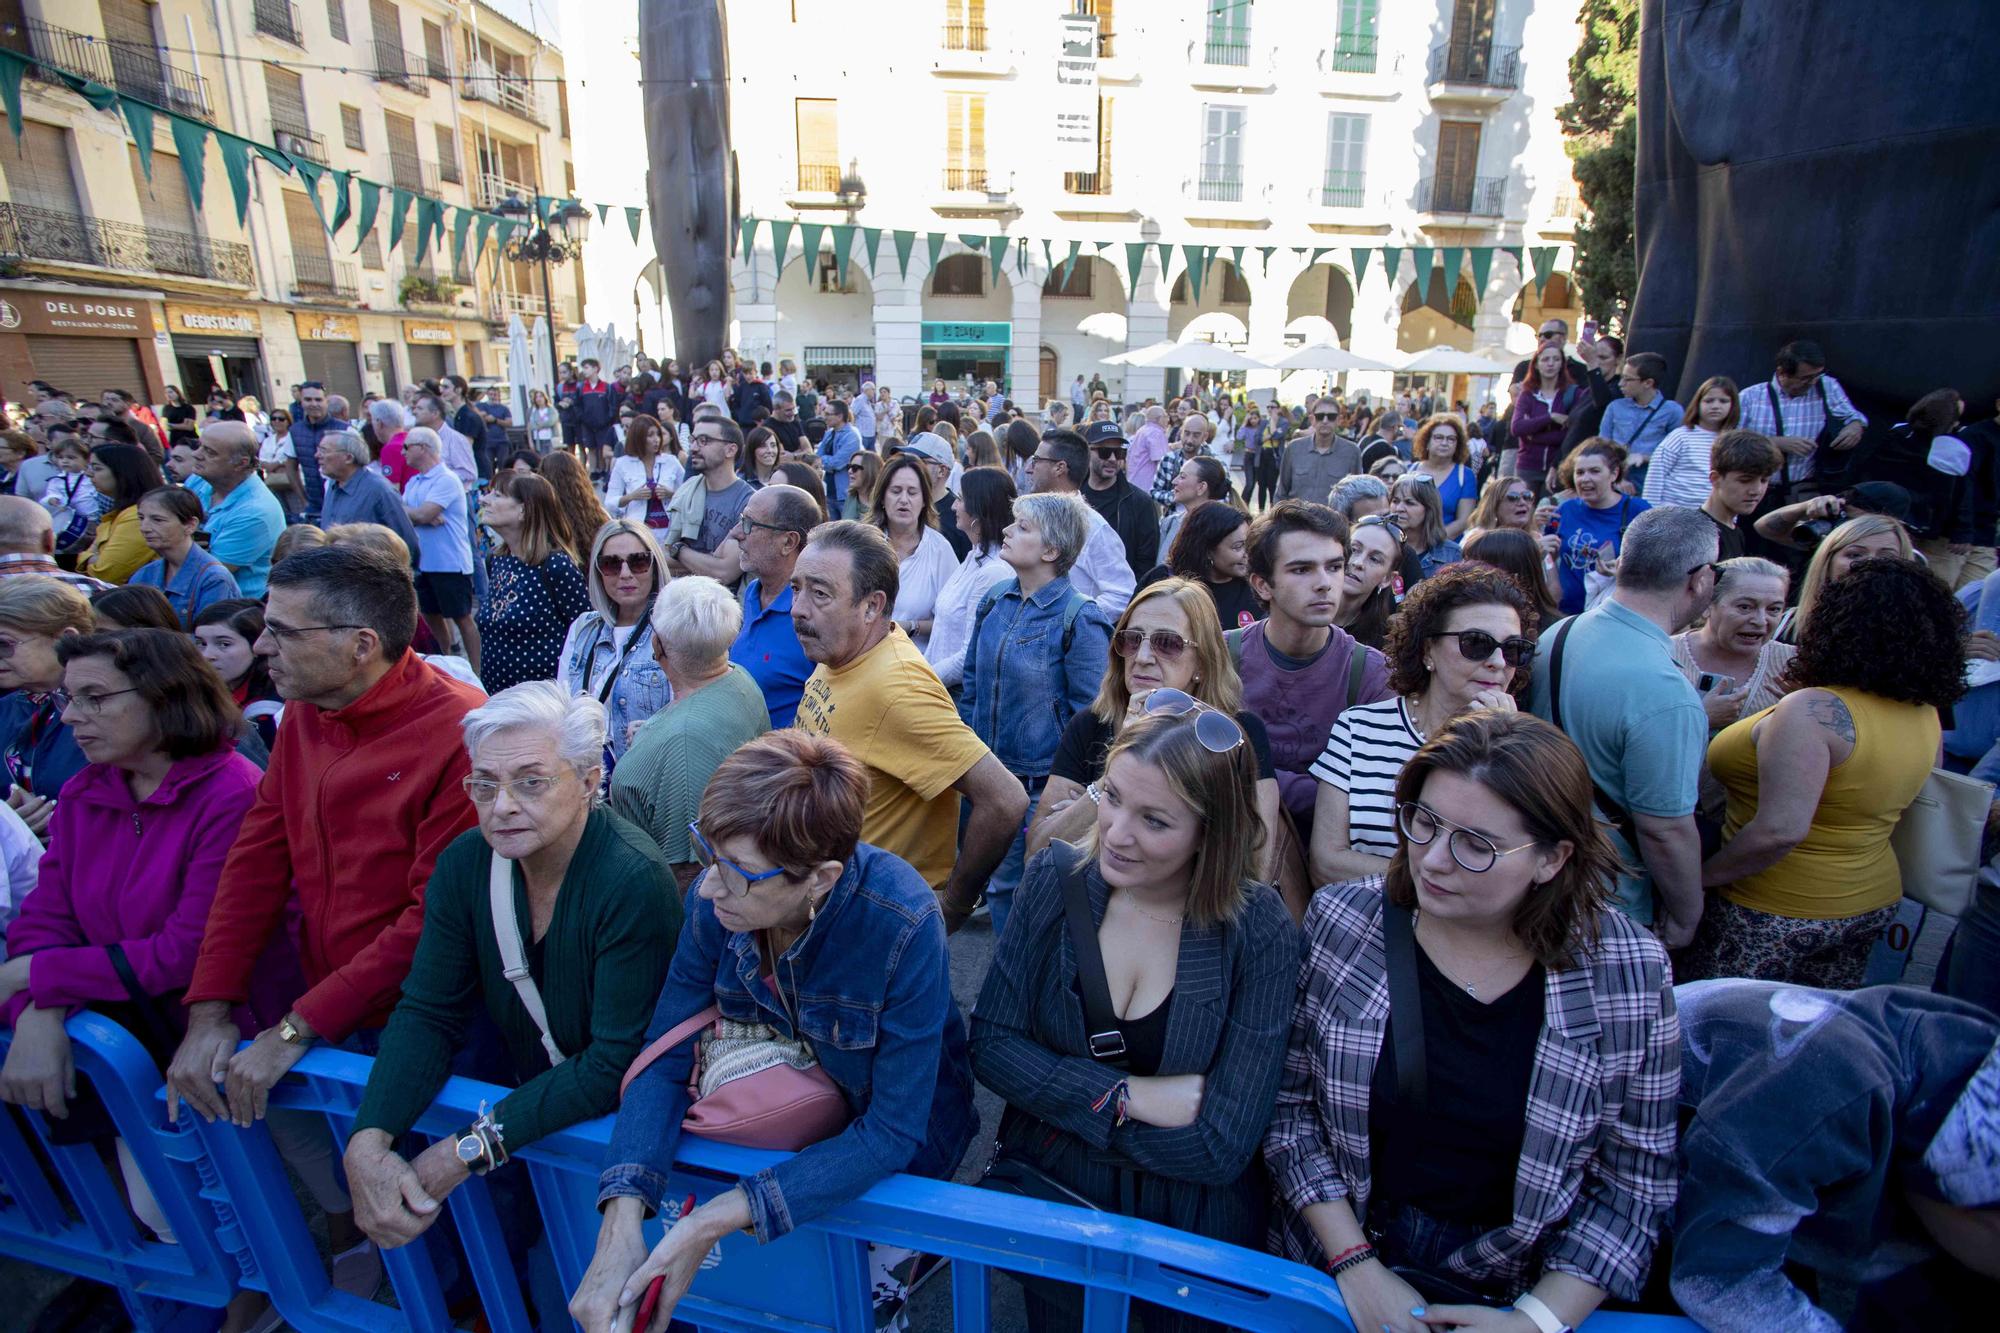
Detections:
0,320,2000,1333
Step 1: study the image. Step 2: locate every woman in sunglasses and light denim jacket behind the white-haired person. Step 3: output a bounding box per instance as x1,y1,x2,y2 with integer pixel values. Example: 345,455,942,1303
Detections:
556,518,674,777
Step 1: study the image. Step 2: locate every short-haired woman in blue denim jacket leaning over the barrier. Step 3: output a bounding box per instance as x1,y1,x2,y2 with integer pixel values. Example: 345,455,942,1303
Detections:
570,731,978,1333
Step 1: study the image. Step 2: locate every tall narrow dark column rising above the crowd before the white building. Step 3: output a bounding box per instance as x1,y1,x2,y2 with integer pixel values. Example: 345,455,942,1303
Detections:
638,0,736,366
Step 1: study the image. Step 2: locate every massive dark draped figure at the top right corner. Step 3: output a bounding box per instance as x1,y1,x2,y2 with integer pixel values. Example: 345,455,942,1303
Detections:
1630,0,2000,422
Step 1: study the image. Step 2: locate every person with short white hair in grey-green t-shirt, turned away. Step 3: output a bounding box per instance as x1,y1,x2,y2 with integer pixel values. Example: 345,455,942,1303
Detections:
612,572,770,876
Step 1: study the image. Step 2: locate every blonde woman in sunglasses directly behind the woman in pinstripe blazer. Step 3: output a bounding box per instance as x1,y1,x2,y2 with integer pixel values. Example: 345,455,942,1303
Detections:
1028,578,1278,869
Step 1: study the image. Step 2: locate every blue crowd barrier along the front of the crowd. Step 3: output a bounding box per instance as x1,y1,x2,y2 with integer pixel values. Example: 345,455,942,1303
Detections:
0,1015,1694,1333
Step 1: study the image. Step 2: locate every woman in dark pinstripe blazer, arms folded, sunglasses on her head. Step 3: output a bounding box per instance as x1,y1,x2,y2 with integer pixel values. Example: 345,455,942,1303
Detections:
972,697,1300,1329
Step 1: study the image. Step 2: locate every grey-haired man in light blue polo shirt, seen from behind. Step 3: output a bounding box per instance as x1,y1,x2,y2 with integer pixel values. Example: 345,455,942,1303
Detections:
1530,506,1718,949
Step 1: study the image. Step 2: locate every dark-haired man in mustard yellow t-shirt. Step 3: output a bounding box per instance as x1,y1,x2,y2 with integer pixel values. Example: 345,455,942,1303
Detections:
792,522,1028,931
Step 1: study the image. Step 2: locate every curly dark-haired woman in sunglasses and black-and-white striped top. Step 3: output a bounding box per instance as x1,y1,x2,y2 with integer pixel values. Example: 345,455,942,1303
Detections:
1310,558,1538,885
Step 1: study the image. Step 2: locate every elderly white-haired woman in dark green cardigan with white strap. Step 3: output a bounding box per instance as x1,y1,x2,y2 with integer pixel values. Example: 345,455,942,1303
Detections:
346,681,680,1247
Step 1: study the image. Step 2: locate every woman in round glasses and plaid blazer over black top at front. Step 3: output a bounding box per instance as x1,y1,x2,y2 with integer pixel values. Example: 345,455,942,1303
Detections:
1264,712,1680,1333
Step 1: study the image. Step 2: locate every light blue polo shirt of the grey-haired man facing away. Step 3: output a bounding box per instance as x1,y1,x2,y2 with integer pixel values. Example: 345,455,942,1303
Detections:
1528,598,1708,925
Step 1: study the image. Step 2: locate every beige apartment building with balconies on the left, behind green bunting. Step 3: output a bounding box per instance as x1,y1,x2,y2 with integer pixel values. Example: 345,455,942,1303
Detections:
0,0,582,410
